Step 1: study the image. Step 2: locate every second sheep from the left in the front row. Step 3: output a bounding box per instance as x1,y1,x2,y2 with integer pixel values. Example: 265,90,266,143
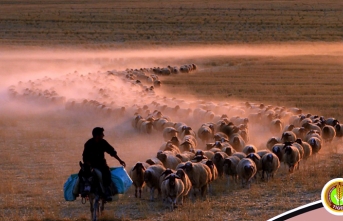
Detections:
144,164,166,201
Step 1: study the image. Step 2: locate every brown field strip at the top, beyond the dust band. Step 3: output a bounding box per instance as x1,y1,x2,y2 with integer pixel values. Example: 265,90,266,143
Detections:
0,0,343,45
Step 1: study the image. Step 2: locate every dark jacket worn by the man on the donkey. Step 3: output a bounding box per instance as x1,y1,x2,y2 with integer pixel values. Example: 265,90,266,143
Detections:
82,138,117,167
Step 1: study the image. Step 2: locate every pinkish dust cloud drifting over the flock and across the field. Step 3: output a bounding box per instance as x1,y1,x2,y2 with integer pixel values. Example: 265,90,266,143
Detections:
0,43,343,165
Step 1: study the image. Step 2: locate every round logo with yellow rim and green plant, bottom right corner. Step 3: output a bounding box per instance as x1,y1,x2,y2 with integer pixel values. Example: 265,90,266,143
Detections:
321,178,343,216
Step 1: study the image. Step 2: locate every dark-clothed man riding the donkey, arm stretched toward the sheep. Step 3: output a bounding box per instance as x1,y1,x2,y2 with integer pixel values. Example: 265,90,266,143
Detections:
80,127,126,202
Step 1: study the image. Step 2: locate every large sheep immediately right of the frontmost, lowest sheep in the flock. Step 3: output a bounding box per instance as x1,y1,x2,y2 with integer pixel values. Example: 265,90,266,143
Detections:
181,162,212,197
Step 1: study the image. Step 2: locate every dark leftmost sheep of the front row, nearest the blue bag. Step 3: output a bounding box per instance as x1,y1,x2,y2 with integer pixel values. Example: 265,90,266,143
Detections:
129,162,150,198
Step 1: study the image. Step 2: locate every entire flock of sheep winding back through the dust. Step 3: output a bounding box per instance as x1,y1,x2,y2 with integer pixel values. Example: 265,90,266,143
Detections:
8,64,343,209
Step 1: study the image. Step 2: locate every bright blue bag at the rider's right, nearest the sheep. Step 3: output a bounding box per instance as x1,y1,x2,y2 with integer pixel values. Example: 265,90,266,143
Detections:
110,167,133,194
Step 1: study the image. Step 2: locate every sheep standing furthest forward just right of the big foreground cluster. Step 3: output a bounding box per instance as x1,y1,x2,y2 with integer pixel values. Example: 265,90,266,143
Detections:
236,158,257,189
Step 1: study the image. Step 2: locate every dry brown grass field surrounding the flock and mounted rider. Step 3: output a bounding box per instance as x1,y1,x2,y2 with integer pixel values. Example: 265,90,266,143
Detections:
0,0,343,221
